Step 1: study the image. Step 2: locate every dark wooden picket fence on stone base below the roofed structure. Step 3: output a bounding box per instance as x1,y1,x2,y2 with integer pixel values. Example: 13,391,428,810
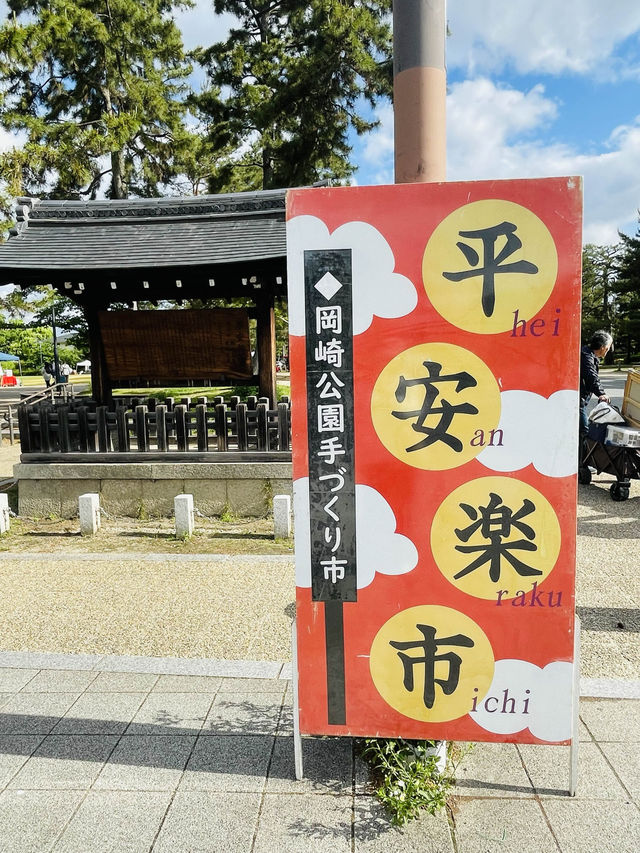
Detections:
18,397,291,462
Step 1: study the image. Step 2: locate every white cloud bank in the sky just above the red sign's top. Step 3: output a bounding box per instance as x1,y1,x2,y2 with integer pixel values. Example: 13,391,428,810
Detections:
361,79,640,244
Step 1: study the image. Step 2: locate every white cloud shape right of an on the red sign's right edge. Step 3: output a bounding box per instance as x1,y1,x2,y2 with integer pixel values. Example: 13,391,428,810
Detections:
477,390,579,477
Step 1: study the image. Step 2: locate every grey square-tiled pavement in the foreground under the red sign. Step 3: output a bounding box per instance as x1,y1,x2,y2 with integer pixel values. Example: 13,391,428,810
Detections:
0,652,640,853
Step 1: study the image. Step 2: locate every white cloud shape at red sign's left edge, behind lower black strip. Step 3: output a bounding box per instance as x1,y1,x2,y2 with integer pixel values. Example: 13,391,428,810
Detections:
293,477,418,589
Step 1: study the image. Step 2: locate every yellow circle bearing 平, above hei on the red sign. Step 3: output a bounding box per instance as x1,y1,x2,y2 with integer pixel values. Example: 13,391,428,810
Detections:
422,199,558,334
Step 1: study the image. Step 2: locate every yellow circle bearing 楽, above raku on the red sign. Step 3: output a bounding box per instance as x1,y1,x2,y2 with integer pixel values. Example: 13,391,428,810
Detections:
431,477,561,602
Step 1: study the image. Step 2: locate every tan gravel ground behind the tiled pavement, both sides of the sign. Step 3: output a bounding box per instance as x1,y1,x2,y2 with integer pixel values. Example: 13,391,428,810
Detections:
0,446,640,679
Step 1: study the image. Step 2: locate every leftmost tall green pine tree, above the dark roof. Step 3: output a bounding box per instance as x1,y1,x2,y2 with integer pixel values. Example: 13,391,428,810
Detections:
0,0,192,198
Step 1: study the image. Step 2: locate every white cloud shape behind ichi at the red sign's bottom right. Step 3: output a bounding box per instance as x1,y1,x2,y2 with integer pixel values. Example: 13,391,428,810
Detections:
469,659,573,743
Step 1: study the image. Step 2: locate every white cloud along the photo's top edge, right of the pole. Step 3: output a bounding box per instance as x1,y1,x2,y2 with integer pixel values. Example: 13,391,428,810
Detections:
447,0,640,76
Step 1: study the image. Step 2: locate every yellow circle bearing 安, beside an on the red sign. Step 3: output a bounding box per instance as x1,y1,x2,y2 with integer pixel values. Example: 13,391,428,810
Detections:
371,343,500,471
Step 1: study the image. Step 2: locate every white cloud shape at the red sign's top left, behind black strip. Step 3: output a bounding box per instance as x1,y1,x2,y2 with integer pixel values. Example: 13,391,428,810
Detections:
287,216,418,335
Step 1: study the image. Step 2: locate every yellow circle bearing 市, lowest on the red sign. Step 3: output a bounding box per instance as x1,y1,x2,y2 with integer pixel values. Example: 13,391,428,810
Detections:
369,605,495,723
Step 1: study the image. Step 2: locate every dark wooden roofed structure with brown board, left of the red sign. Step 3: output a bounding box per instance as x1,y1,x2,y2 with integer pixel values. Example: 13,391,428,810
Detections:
0,190,286,405
